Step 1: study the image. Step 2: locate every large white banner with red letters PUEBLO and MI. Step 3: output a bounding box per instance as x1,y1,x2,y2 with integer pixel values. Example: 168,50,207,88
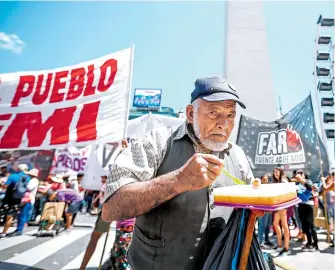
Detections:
0,48,133,150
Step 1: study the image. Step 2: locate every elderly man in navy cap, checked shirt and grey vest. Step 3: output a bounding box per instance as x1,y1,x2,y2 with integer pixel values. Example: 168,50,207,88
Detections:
102,76,253,270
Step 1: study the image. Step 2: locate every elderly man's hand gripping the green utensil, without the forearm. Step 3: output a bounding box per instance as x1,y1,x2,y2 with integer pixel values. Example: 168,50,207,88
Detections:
176,153,224,193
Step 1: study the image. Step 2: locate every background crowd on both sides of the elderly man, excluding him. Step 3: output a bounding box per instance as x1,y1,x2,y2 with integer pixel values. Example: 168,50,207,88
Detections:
0,156,335,269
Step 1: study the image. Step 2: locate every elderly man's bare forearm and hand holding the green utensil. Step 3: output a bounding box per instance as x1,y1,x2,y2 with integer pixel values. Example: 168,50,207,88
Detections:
102,154,223,222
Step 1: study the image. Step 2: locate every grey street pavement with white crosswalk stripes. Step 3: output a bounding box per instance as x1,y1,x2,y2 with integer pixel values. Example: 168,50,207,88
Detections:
0,213,334,270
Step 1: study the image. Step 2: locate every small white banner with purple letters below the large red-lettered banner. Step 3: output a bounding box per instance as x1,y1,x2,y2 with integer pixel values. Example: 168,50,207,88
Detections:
50,145,92,175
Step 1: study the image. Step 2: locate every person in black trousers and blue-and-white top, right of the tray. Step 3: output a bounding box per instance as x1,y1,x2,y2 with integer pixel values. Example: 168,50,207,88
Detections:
296,170,319,250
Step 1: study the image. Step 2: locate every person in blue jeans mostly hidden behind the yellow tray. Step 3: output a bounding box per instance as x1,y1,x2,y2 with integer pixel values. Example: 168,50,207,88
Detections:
258,174,273,249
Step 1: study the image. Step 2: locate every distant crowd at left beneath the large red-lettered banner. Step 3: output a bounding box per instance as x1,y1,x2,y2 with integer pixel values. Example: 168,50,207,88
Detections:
0,164,98,235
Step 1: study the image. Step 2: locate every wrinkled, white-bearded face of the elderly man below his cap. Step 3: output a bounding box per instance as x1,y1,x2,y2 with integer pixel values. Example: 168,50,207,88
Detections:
186,99,236,151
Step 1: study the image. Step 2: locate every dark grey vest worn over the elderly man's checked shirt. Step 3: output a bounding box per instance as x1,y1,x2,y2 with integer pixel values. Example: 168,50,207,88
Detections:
128,135,208,270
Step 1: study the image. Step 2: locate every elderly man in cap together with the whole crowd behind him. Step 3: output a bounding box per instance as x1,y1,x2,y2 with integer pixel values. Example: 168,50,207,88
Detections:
0,76,334,269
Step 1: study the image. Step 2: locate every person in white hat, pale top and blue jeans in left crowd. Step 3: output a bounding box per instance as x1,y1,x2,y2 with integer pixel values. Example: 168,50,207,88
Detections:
11,169,39,236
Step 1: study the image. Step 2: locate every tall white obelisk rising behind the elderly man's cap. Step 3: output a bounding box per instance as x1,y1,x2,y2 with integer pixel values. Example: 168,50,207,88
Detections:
224,1,277,141
